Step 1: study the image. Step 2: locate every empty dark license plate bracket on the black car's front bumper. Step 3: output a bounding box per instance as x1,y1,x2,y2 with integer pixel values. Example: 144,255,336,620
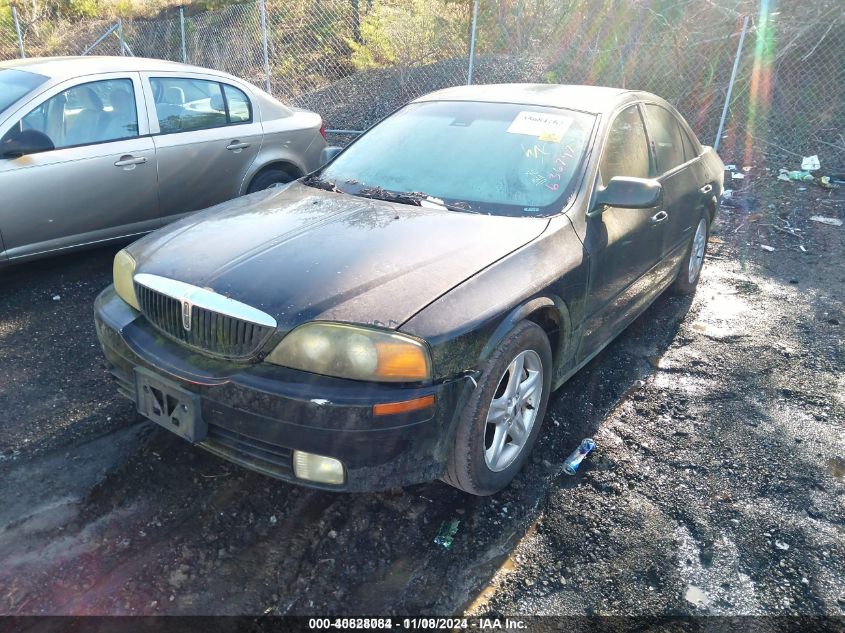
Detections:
135,367,208,444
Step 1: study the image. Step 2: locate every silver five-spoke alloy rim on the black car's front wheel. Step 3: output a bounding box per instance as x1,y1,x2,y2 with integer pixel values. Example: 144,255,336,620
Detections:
484,349,543,472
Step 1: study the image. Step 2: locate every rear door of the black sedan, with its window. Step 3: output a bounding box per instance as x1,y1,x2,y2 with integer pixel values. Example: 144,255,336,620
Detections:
645,103,708,261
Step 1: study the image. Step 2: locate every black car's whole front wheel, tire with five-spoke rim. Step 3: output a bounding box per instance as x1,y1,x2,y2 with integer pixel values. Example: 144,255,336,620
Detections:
443,321,552,496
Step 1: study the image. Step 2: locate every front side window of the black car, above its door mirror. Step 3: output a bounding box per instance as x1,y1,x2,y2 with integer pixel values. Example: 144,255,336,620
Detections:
600,105,651,184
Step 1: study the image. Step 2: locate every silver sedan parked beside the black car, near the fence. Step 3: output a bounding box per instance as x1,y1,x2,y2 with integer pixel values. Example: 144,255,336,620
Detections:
0,57,325,266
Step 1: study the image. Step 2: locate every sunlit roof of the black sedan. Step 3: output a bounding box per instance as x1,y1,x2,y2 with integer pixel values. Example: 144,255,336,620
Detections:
416,84,644,113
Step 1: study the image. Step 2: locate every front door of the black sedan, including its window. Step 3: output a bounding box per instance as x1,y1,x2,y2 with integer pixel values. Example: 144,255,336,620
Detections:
579,104,666,359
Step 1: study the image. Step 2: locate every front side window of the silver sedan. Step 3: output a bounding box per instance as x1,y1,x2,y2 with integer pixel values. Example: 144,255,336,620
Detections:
6,79,138,149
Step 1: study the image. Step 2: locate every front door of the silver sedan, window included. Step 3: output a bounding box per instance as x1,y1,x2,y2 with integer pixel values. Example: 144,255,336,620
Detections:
0,73,158,259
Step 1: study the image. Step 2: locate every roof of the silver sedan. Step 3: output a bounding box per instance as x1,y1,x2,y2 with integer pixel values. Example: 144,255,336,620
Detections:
0,56,231,79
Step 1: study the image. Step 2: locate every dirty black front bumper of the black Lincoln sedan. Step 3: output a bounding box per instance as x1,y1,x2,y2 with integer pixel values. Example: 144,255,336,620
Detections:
94,286,473,492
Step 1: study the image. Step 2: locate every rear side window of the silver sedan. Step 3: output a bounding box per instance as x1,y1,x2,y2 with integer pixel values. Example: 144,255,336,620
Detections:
150,77,252,134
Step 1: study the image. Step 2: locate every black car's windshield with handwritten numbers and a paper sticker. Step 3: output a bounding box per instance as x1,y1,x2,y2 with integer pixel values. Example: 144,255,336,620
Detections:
320,101,595,216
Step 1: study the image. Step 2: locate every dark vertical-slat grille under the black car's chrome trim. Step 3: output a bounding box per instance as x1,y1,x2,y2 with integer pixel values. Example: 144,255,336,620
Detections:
135,283,273,359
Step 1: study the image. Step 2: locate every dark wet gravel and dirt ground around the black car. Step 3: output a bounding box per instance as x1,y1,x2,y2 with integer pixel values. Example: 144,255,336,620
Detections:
0,168,845,615
